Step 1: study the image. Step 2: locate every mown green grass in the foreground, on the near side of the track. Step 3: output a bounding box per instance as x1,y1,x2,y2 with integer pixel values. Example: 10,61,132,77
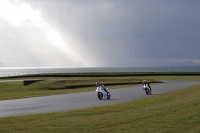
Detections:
0,85,200,133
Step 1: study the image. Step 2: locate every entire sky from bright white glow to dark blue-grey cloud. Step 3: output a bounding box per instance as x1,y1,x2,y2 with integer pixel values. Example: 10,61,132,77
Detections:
0,0,200,68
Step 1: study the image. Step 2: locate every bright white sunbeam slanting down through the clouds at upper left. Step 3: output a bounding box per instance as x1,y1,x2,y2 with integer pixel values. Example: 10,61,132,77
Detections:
0,1,88,66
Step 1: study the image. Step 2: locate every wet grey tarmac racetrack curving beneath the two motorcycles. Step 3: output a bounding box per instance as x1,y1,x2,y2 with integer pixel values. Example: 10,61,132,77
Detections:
0,81,200,117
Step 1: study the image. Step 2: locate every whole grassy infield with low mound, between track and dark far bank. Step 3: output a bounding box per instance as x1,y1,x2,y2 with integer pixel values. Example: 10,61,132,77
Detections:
0,76,200,100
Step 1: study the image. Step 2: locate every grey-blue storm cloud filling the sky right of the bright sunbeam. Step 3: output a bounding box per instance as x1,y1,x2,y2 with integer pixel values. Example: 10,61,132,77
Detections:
3,0,200,67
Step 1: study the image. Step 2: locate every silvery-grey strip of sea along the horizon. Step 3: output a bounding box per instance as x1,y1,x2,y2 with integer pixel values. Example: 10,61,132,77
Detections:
0,66,200,77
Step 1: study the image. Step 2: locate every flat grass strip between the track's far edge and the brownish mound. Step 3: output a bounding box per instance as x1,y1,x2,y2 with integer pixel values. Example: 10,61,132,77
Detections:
0,82,142,100
